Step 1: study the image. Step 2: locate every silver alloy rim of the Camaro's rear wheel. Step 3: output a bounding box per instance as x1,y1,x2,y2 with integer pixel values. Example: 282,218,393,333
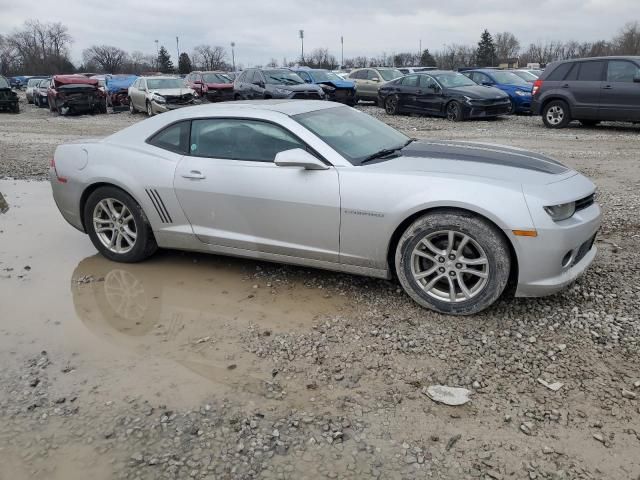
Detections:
93,198,138,254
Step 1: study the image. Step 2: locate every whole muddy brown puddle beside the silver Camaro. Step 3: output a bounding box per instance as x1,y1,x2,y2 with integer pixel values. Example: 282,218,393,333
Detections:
0,181,349,408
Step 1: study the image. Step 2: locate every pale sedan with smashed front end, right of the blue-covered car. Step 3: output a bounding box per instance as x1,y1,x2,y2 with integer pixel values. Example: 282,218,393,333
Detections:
129,77,196,117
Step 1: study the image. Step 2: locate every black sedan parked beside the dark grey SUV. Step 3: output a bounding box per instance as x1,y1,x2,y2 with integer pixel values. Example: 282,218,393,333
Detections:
378,70,511,122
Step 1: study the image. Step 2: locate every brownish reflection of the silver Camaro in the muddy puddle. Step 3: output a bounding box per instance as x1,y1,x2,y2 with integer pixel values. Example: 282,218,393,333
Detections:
71,252,346,394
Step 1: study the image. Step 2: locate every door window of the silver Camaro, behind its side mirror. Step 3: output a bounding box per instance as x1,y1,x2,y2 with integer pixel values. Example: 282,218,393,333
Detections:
189,118,306,162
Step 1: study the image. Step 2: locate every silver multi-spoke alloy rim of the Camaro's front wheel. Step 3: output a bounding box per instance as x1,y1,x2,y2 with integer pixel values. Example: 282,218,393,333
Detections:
411,230,490,303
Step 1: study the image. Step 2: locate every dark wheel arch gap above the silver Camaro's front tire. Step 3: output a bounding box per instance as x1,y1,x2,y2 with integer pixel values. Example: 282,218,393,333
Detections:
387,206,519,288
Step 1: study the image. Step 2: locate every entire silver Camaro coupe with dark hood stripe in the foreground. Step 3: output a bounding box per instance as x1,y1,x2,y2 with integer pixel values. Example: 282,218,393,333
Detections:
50,100,601,314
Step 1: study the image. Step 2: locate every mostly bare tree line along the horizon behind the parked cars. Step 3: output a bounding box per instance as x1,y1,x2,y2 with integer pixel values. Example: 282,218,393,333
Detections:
0,20,640,75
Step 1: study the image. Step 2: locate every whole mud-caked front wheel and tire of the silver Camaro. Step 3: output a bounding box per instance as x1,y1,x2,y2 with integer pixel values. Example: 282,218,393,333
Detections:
395,210,511,315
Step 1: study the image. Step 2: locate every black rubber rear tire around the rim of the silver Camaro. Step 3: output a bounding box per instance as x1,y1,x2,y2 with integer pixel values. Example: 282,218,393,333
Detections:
83,187,158,263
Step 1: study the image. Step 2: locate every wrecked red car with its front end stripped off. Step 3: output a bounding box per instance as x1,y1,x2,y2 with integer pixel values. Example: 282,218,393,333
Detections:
48,75,102,115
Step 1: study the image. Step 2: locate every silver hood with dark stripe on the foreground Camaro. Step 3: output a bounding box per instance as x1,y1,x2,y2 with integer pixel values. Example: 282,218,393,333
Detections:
371,140,576,184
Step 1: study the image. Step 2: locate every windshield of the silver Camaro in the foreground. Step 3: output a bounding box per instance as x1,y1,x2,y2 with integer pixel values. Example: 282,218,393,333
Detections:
293,107,409,165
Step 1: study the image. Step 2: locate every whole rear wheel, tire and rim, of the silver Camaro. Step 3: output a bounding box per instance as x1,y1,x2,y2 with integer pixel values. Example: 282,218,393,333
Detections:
84,187,158,263
